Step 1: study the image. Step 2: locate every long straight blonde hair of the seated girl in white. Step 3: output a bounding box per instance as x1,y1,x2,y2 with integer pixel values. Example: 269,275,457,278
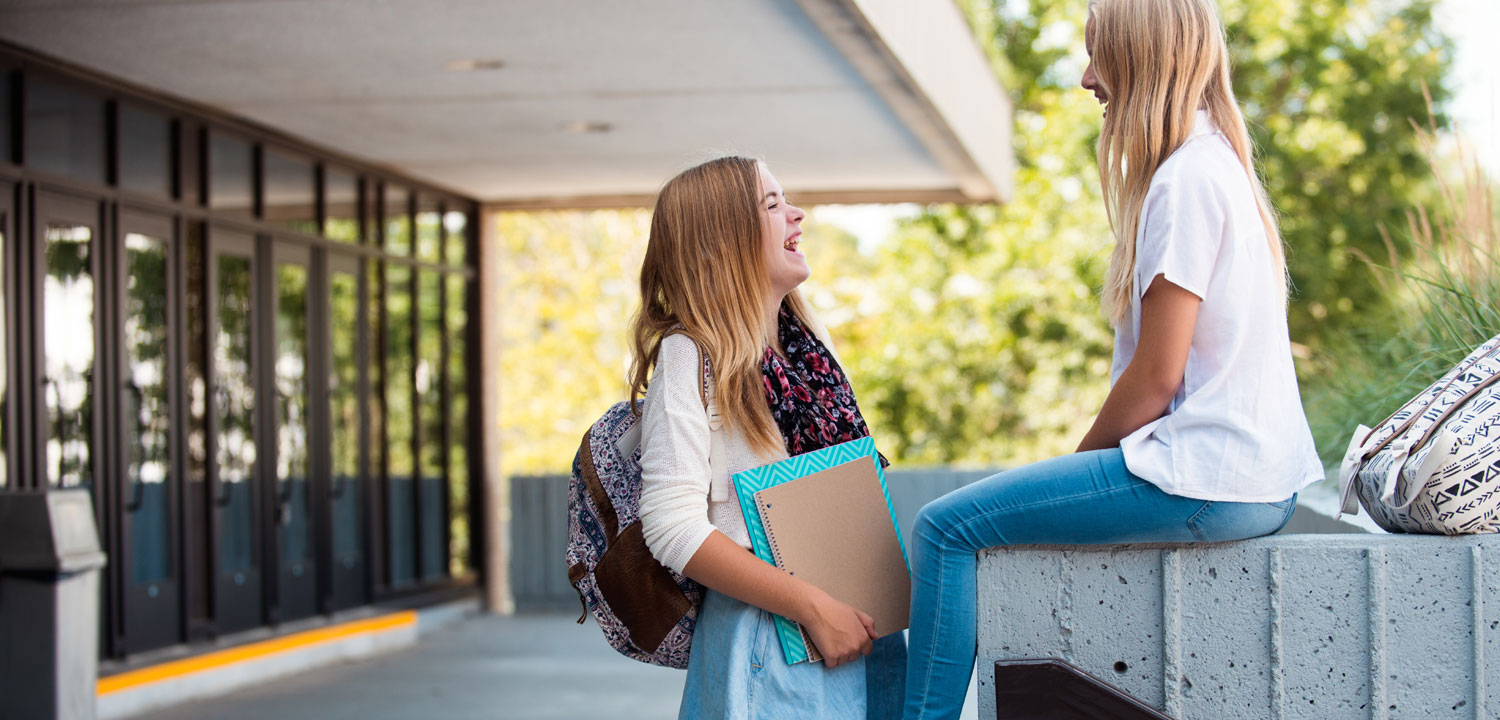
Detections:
1088,0,1287,324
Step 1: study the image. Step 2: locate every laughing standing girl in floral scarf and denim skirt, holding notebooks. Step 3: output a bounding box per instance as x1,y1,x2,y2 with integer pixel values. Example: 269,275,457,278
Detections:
632,158,906,719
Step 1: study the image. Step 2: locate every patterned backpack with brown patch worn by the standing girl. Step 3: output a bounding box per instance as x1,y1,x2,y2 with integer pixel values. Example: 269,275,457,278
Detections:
567,345,713,669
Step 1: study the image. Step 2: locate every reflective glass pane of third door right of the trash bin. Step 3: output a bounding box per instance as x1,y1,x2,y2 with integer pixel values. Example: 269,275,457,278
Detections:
276,263,312,576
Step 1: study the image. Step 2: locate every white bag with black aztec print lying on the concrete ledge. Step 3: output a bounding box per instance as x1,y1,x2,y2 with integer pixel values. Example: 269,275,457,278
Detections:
1338,336,1500,536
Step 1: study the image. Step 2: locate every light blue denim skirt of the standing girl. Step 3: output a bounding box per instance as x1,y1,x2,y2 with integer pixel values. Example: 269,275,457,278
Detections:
678,591,906,720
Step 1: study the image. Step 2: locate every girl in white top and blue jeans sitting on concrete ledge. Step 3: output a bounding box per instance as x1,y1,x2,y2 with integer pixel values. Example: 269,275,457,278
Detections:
906,0,1323,720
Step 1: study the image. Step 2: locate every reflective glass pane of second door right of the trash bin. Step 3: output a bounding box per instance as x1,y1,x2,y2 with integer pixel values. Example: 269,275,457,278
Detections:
213,255,255,575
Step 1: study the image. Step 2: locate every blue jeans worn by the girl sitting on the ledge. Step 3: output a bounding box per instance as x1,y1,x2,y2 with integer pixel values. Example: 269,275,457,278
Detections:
905,449,1296,720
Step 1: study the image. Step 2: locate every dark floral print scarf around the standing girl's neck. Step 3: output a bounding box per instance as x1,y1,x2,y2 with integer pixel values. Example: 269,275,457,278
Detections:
761,305,890,467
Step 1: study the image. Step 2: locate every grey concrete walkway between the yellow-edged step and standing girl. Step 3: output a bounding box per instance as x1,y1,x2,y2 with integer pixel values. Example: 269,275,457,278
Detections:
138,612,975,720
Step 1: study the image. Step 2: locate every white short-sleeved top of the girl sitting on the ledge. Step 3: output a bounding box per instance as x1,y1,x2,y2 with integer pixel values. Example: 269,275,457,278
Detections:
1110,111,1323,503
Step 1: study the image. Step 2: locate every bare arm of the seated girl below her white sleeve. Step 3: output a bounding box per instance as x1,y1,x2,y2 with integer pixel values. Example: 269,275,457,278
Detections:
1079,275,1203,453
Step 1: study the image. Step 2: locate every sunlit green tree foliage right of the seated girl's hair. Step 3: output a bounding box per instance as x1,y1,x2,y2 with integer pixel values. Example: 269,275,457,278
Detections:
1224,0,1452,350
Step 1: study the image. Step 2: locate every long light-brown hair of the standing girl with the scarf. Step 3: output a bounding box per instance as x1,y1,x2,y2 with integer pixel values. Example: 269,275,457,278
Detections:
630,156,827,452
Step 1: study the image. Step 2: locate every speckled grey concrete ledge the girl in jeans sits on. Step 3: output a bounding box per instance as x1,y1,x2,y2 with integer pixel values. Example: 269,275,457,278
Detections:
978,534,1500,720
